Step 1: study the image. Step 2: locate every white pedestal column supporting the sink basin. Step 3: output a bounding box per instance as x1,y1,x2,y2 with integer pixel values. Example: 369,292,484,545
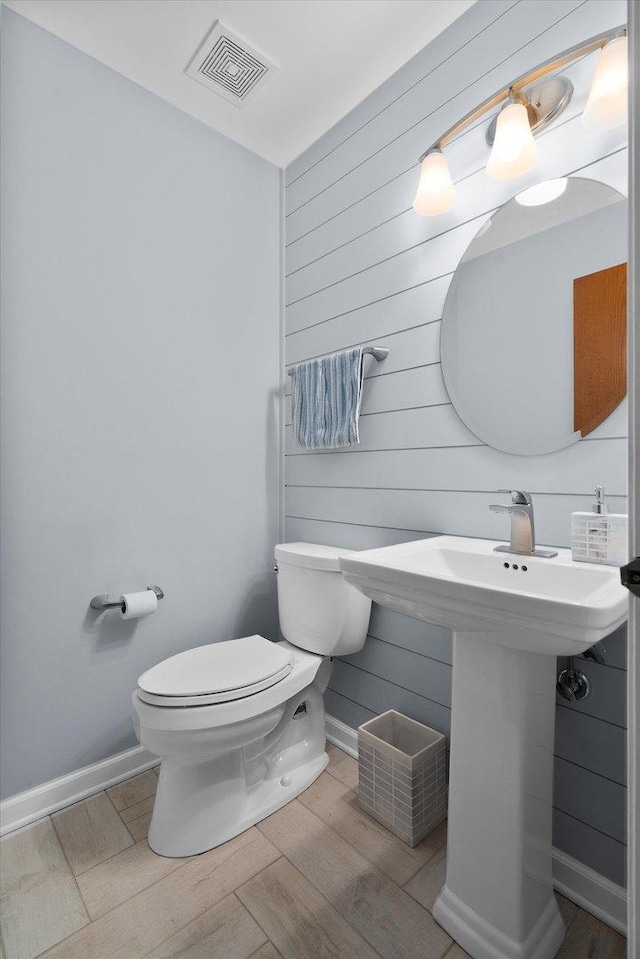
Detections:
433,632,565,959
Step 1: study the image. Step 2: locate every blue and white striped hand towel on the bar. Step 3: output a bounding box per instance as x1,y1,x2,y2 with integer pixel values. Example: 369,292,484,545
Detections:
291,346,362,449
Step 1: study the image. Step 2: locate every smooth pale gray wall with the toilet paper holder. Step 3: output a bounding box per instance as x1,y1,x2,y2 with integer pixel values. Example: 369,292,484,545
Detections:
1,9,280,796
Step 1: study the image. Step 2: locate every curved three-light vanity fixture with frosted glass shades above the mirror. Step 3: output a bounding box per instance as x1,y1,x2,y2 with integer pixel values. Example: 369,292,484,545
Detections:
413,27,629,216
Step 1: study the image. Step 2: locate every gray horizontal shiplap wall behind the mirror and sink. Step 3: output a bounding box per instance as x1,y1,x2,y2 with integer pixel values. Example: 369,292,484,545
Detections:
286,0,627,883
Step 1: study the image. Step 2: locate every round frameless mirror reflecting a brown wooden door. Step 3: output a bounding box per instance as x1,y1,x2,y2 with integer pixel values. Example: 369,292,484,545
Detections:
441,177,628,455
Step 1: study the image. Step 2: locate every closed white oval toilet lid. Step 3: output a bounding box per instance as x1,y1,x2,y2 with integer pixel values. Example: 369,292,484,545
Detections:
138,636,294,706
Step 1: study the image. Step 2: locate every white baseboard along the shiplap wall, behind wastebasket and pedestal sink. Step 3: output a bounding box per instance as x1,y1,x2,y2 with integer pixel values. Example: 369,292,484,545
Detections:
326,716,627,935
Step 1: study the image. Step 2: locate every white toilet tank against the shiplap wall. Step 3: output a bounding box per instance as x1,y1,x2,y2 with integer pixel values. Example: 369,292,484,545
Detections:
275,543,371,656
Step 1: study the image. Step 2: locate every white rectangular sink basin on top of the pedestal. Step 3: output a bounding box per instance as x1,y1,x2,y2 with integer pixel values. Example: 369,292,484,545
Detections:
340,536,627,656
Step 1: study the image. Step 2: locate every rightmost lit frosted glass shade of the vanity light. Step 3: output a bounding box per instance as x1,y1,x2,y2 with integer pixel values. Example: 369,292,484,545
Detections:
582,37,629,130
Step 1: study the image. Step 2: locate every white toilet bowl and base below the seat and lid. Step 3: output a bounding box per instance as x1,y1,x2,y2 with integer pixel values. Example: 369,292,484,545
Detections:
144,671,329,858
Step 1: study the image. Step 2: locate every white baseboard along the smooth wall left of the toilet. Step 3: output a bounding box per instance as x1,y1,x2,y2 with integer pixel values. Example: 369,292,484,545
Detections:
0,746,159,836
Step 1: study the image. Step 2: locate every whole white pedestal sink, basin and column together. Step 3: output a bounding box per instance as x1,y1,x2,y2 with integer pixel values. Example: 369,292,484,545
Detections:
340,536,627,959
